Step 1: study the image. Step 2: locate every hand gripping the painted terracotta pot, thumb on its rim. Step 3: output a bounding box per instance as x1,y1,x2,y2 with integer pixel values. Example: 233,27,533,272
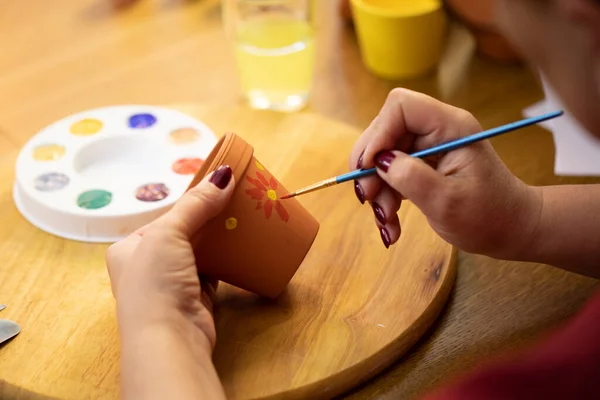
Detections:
106,166,235,350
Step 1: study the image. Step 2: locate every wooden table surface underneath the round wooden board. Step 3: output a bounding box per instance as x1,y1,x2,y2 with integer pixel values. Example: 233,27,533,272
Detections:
0,0,600,399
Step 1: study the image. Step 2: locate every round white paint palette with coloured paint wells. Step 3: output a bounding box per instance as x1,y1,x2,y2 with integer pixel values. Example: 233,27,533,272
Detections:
13,105,217,243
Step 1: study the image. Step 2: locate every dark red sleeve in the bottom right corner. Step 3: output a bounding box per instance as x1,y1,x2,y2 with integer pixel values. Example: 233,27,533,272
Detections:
424,294,600,400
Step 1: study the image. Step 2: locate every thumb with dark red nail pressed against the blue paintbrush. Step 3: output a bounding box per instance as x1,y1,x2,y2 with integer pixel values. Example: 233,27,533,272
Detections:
375,151,446,215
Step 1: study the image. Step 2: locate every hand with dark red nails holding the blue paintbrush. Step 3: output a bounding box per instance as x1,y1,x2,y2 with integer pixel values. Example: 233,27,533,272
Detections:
350,89,542,258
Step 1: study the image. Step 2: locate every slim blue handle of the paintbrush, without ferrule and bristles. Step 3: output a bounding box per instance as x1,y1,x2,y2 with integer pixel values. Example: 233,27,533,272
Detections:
335,110,564,183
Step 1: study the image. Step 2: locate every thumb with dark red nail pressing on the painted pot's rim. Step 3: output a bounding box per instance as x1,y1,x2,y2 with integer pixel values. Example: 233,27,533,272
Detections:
157,165,235,239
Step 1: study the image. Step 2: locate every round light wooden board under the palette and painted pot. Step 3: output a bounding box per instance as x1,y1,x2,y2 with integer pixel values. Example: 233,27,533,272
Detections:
0,105,456,400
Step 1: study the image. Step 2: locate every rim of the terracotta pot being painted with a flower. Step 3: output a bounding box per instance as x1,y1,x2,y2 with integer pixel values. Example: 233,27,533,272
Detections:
187,132,254,190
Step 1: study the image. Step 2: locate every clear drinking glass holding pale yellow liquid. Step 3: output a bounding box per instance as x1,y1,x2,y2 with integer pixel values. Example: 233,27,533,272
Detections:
223,0,315,111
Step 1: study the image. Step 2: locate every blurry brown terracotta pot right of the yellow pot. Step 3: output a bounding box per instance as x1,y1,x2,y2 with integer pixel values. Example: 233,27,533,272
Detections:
446,0,521,63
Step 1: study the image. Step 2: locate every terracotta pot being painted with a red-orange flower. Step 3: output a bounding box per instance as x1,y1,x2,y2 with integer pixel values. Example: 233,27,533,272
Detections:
188,133,319,298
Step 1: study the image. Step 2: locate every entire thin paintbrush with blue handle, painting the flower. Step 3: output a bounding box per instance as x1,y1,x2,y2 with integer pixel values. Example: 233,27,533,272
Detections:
281,110,564,199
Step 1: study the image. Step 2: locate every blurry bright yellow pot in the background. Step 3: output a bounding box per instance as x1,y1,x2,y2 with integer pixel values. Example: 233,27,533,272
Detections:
351,0,447,79
